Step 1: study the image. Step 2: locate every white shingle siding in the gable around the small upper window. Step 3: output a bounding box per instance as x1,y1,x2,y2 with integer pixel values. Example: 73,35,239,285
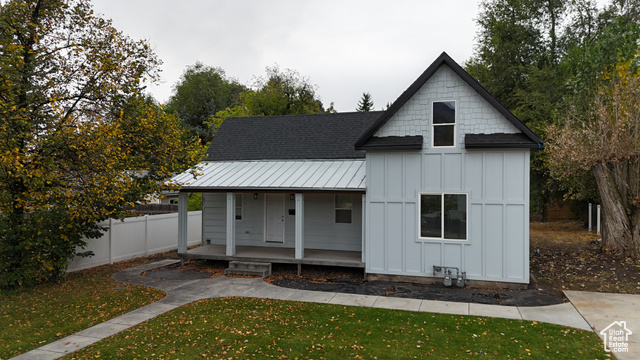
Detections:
374,65,520,148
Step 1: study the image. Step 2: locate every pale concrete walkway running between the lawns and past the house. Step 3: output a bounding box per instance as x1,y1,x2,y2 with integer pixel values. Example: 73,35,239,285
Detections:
13,260,608,360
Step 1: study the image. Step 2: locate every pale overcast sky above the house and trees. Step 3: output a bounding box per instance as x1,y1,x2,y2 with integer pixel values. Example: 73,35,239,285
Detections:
93,0,490,112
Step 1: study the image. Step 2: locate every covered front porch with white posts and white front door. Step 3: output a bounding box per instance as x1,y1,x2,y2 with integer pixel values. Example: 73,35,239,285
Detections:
178,191,365,268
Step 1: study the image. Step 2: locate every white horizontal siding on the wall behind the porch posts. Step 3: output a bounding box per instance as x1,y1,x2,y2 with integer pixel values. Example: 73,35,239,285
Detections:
202,193,362,251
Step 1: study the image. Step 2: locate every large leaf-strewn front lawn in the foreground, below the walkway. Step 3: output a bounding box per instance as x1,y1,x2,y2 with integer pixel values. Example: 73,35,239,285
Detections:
65,298,608,359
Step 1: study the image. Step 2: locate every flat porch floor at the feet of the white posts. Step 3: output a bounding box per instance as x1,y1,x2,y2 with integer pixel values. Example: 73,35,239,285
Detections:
178,245,364,268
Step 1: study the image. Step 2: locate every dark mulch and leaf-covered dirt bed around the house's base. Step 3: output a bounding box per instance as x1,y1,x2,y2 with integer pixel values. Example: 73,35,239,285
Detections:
131,221,640,306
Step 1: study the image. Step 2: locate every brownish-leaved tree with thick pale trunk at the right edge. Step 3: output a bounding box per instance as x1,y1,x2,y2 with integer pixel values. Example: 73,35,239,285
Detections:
548,61,640,259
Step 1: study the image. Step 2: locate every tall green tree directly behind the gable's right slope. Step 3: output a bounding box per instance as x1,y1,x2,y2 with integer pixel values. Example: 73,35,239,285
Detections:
466,0,580,214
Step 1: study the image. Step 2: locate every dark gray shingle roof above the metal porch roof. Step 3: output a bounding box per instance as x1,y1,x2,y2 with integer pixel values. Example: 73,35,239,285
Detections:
205,111,383,161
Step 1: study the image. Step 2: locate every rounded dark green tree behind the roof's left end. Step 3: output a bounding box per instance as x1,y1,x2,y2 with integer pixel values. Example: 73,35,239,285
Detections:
166,62,246,144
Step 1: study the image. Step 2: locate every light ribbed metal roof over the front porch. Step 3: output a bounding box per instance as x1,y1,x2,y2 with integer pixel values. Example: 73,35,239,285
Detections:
172,160,366,191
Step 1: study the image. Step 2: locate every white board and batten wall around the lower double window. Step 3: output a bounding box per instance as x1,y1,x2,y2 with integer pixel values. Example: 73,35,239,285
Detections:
366,150,529,283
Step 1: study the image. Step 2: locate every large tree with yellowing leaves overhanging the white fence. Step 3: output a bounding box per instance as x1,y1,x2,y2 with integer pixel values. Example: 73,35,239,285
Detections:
0,0,200,287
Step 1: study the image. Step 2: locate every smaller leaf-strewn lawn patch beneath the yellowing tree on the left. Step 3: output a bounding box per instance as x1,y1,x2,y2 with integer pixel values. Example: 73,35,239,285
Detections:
0,262,164,359
